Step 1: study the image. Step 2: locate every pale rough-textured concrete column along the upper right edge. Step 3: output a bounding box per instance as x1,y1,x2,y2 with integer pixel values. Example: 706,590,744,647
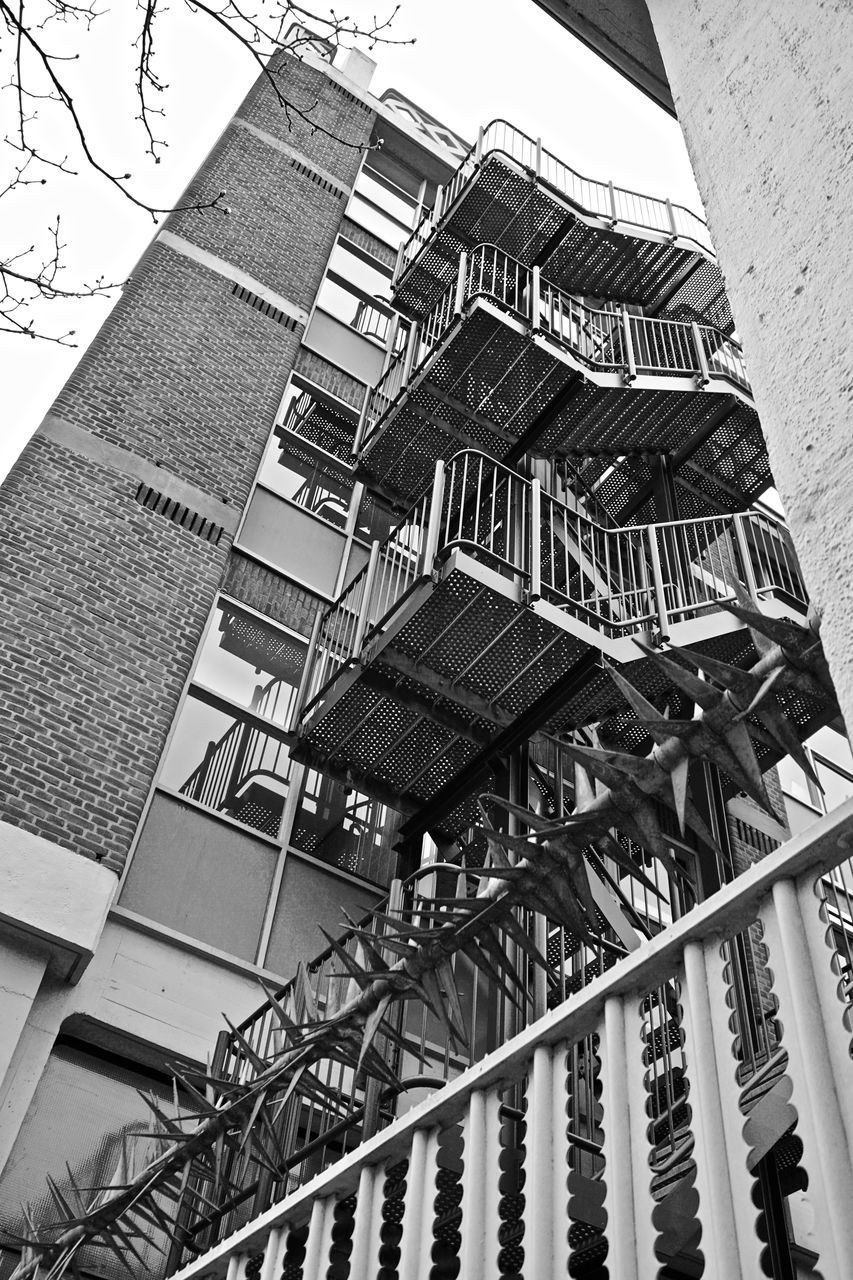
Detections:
648,0,853,727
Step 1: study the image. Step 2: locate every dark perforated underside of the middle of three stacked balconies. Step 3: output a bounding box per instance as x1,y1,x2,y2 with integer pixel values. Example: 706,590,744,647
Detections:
359,303,758,513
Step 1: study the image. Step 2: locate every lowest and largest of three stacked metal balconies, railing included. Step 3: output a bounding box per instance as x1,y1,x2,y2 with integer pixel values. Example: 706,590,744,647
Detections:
296,451,808,835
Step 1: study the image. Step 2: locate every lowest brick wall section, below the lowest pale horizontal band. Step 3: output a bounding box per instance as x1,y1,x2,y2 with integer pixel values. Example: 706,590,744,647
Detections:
0,438,228,865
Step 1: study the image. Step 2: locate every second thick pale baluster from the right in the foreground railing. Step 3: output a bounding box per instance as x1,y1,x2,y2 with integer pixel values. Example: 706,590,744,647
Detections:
681,937,761,1280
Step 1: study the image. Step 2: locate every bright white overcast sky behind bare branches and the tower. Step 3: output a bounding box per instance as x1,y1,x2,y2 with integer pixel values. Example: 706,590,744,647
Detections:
0,0,702,476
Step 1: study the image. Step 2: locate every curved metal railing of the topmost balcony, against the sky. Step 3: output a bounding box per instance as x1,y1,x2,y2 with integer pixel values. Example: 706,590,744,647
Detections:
394,120,713,282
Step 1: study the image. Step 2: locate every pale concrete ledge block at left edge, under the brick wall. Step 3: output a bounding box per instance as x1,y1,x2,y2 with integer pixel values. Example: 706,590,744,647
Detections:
0,822,118,983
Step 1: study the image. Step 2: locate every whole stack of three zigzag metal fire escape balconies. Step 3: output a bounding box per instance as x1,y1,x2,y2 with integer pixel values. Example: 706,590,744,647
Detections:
289,122,816,838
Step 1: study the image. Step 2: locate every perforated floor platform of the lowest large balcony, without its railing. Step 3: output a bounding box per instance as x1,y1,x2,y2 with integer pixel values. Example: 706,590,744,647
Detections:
298,481,813,838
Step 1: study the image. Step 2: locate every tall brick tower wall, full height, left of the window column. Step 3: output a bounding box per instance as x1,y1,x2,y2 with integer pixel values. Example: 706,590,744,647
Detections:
0,47,373,869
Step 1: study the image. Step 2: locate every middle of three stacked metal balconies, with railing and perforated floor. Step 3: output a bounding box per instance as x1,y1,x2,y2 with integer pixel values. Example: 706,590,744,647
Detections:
355,244,771,511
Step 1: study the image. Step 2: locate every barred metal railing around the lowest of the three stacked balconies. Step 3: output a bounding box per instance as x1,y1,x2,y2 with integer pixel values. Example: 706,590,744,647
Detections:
300,449,807,718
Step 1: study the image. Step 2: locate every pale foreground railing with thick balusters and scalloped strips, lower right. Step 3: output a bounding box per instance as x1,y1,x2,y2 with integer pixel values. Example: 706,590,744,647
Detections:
167,801,853,1280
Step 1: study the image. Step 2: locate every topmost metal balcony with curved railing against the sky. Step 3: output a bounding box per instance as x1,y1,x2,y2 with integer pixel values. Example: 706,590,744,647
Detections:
394,120,733,333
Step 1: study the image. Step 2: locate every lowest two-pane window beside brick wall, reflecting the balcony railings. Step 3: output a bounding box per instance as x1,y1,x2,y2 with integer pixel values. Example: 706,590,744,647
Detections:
160,602,306,837
